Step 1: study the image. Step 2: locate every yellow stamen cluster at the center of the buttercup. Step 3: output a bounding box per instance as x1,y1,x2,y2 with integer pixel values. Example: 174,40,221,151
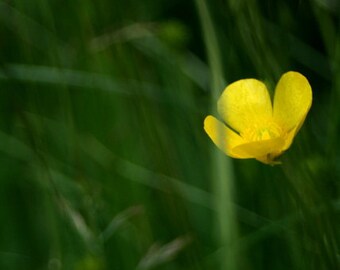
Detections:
241,122,283,142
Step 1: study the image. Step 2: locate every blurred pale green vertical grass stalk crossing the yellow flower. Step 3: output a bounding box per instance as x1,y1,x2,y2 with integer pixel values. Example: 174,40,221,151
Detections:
196,0,238,270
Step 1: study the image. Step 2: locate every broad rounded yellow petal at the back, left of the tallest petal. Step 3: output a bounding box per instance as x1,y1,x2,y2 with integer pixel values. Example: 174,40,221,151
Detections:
217,79,272,133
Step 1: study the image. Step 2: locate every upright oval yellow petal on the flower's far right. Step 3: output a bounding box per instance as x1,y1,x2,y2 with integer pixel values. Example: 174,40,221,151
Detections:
273,71,312,131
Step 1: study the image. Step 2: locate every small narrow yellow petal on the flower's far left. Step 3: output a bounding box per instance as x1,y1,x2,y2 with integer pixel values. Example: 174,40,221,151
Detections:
204,115,244,158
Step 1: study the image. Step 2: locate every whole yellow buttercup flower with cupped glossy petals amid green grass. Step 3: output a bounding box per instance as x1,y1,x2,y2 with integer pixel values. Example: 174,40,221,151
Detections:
204,71,312,164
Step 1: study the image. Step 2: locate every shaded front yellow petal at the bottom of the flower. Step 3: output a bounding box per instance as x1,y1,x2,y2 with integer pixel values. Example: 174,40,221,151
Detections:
232,137,285,159
